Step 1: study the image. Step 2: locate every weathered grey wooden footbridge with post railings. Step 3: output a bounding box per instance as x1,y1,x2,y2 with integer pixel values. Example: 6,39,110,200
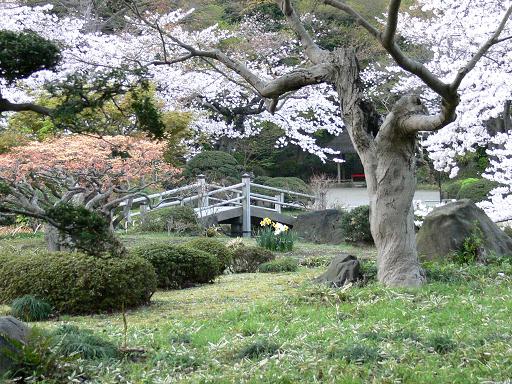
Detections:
120,174,315,237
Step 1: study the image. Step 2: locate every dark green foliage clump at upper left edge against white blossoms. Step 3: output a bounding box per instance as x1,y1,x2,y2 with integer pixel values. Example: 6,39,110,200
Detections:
0,31,60,84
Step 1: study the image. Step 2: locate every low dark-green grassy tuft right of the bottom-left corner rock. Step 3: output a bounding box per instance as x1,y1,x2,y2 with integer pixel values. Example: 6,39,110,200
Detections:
51,325,119,360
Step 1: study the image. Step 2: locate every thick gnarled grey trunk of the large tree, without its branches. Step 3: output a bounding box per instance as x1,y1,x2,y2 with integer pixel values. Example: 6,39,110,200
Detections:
333,49,424,286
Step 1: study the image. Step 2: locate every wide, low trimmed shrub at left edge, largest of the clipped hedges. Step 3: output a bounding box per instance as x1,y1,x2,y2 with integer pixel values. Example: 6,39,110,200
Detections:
0,252,156,314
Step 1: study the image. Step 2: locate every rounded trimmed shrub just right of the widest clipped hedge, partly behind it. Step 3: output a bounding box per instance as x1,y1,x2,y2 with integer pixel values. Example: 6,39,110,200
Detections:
132,244,221,289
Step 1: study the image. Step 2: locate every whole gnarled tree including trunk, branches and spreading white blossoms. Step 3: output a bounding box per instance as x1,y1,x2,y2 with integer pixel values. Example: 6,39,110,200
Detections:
1,0,512,286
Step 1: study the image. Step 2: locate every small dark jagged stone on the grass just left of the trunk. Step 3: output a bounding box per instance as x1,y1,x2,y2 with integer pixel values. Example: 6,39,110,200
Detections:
313,253,362,287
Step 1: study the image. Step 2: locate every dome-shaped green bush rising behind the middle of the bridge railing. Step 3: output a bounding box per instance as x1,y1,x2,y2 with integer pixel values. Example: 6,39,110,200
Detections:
183,151,241,181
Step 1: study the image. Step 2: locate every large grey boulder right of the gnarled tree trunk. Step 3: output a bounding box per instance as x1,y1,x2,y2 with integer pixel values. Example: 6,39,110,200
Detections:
416,199,512,260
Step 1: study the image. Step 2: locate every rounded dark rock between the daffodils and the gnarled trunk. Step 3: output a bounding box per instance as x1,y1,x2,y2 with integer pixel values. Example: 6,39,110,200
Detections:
293,209,343,244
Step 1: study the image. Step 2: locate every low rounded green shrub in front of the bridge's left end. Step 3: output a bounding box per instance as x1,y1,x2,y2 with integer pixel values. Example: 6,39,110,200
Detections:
137,206,199,234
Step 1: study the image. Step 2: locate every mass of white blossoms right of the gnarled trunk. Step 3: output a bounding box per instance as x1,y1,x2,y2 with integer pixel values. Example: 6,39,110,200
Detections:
363,0,512,221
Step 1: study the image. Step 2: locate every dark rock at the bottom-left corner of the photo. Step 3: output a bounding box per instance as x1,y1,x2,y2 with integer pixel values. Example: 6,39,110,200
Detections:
0,316,30,376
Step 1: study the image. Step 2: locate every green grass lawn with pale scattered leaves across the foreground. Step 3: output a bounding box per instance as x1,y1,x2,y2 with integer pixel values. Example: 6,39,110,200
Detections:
0,235,512,383
